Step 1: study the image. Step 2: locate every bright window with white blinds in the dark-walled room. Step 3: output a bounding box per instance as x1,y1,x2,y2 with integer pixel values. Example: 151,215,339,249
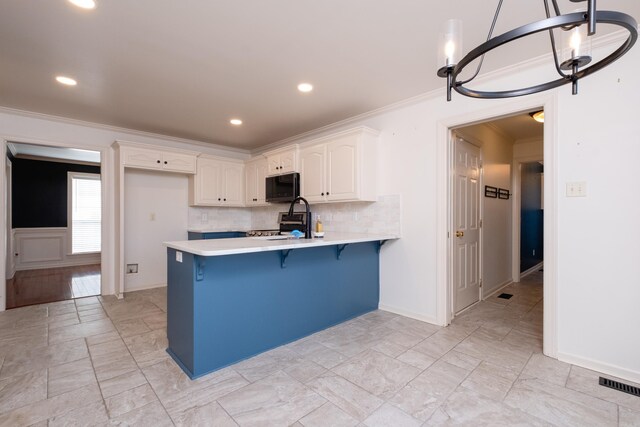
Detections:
68,172,102,254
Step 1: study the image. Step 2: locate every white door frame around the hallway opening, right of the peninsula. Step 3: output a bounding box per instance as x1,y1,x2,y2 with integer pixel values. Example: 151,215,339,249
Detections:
436,93,558,358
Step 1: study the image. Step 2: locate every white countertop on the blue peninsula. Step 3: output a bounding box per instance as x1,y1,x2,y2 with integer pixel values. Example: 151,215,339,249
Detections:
163,232,398,256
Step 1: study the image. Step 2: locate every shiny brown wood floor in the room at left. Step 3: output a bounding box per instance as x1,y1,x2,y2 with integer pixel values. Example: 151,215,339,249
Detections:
7,264,100,309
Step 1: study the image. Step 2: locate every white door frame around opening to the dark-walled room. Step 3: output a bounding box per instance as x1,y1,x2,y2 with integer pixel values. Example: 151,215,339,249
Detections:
0,135,113,312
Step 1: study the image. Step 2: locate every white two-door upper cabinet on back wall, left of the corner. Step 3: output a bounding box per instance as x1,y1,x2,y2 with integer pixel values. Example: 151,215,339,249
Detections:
189,156,244,207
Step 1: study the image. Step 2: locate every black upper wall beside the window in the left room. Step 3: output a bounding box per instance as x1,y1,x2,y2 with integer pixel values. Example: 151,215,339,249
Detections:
11,158,100,228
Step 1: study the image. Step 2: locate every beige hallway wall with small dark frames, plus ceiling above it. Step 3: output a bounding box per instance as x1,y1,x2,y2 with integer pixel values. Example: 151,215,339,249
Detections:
456,124,513,298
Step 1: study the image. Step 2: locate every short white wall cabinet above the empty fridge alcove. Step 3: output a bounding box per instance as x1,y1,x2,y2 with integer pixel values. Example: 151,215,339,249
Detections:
121,146,196,174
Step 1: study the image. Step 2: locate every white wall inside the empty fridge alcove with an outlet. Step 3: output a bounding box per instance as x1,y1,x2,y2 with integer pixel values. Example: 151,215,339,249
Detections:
124,169,189,292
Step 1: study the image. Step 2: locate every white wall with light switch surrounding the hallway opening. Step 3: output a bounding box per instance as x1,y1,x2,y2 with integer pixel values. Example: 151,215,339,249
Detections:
258,36,640,381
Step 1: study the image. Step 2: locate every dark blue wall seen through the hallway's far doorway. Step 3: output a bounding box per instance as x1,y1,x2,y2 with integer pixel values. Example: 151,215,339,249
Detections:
520,162,544,272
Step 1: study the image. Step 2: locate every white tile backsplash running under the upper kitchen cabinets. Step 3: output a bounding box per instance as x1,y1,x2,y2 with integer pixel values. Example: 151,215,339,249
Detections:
189,194,402,235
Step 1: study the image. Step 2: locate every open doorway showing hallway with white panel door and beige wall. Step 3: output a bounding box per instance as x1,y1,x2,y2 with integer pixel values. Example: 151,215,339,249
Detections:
449,109,544,317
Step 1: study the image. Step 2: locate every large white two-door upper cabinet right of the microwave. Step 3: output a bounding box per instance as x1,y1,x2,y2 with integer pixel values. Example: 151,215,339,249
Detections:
300,127,378,203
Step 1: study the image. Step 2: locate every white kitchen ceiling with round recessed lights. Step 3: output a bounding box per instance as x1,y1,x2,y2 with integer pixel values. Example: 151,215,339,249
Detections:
0,0,640,149
